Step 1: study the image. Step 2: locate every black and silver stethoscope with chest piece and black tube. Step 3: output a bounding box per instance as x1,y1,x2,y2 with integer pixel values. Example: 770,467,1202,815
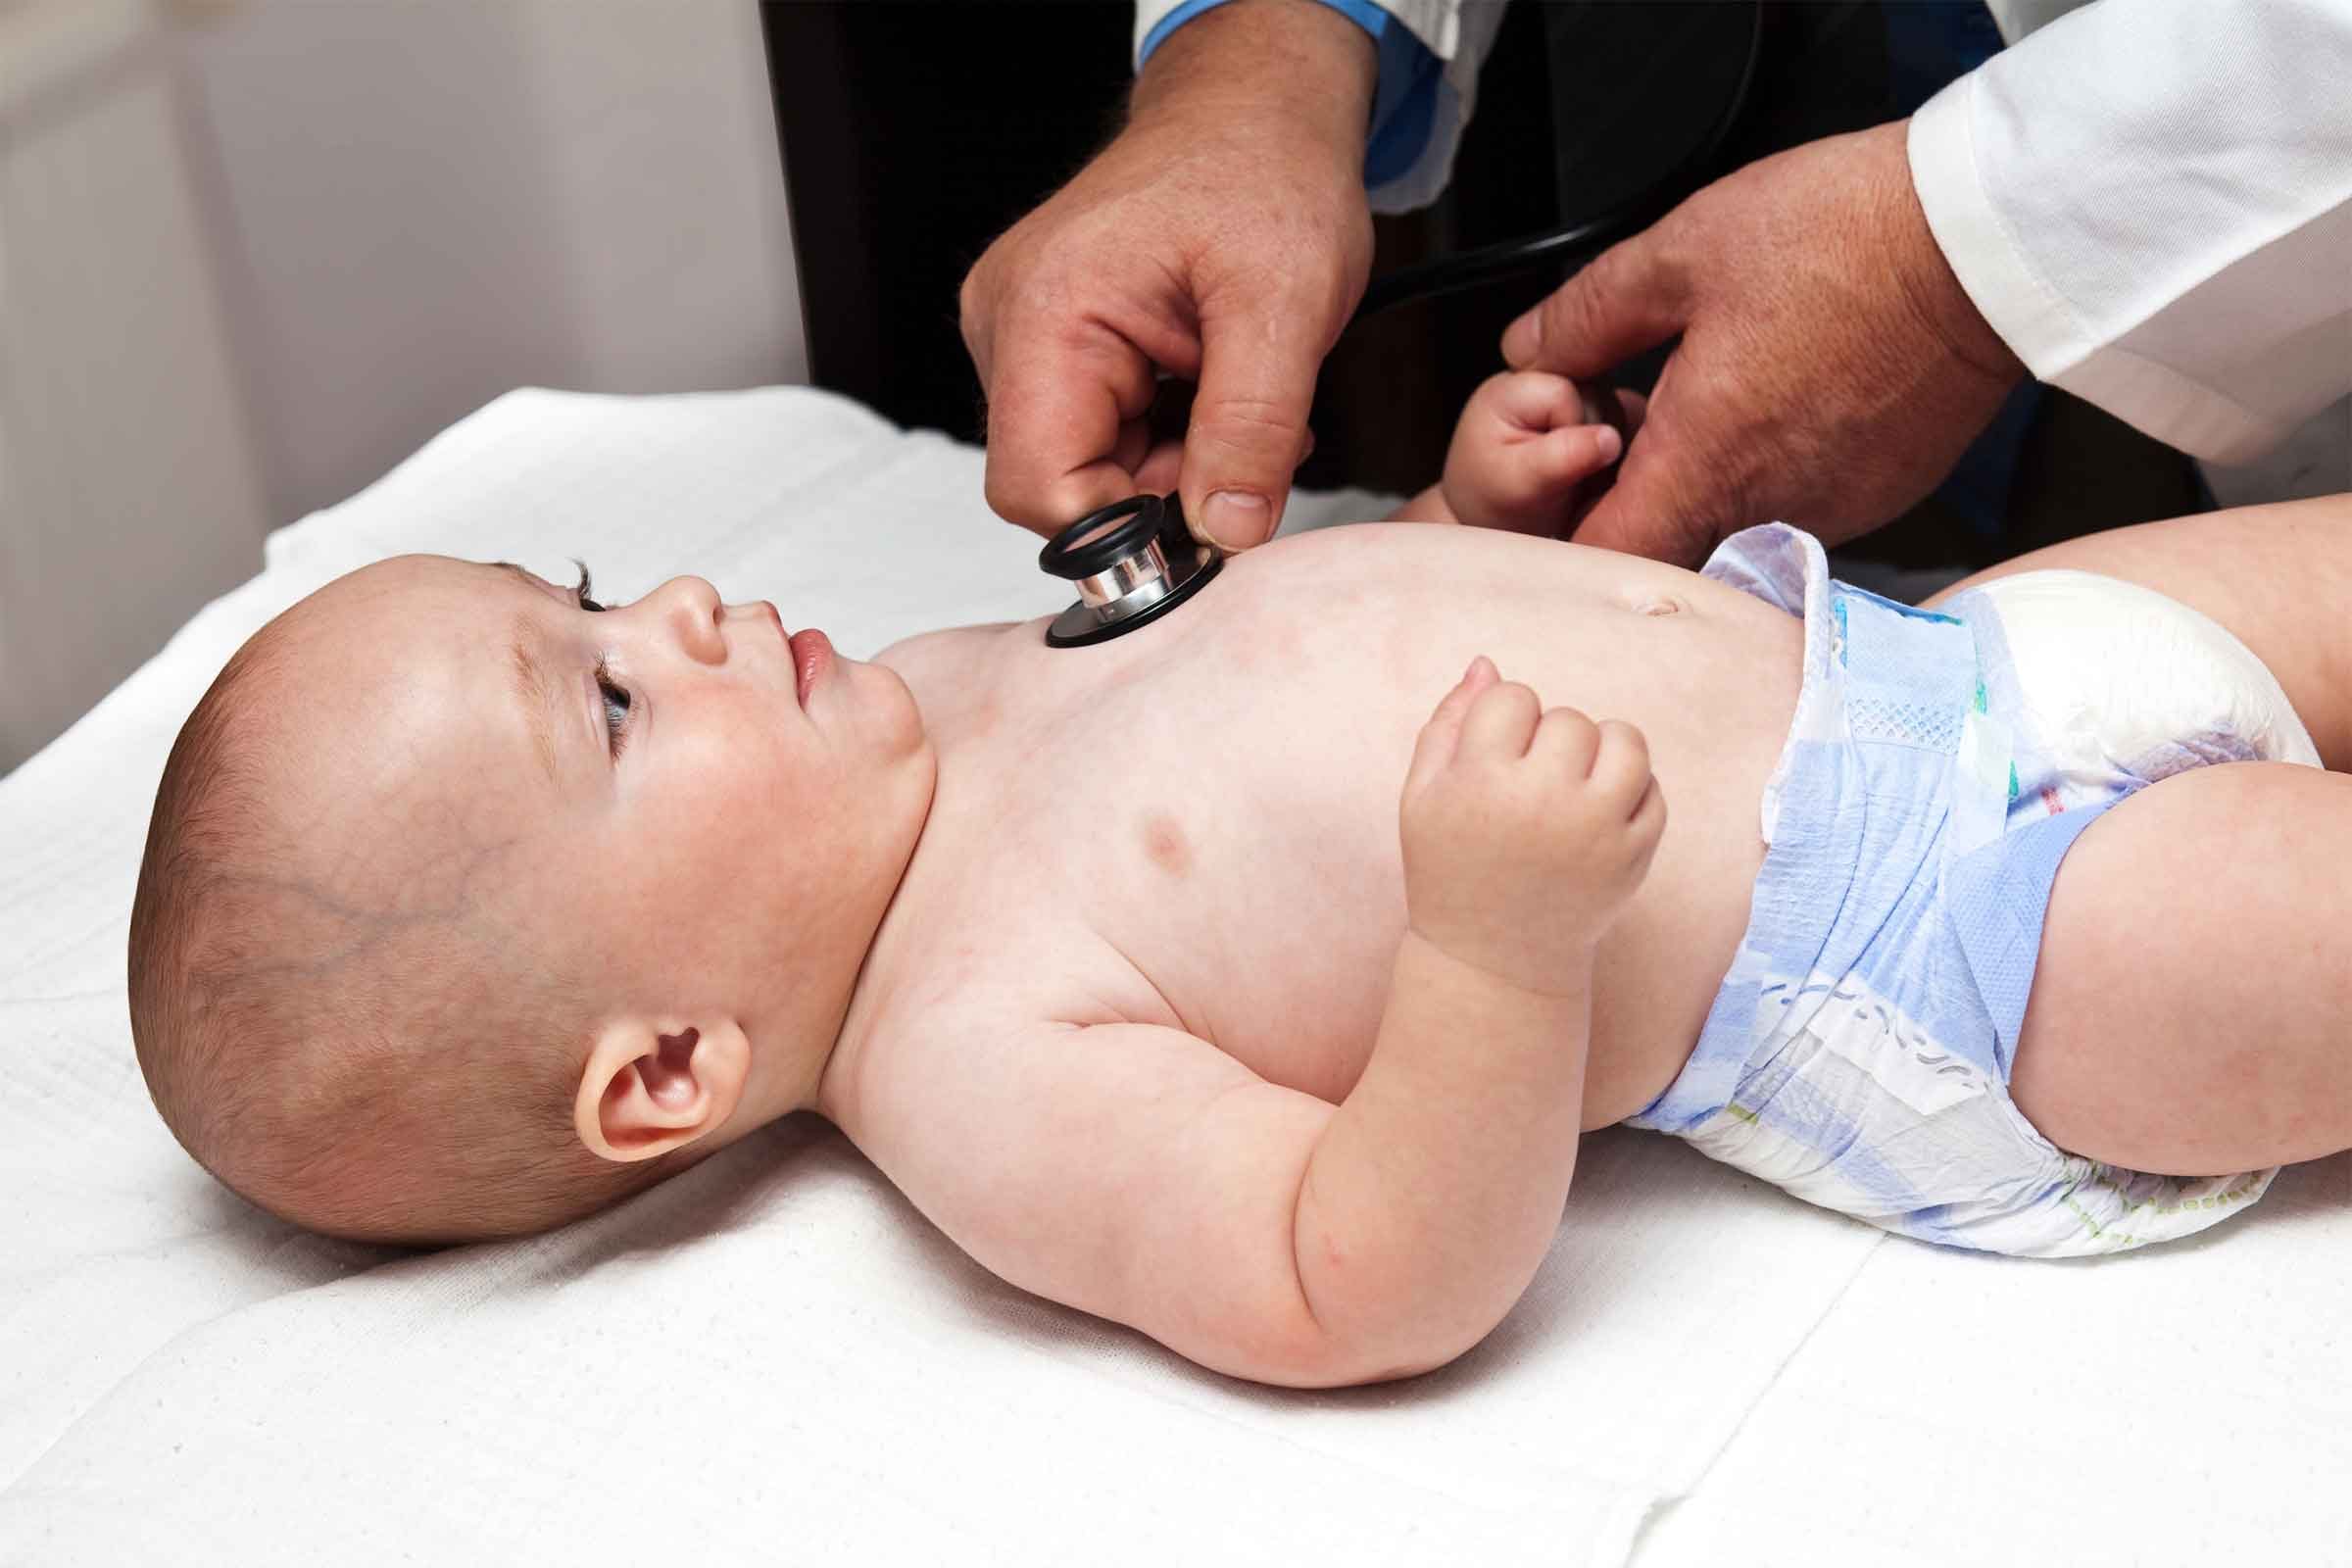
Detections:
1037,2,1764,649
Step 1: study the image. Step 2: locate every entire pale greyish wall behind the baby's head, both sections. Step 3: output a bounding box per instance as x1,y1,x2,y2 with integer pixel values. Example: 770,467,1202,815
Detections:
0,0,807,771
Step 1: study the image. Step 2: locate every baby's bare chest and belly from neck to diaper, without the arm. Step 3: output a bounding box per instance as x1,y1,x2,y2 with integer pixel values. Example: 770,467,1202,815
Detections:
889,535,1794,1119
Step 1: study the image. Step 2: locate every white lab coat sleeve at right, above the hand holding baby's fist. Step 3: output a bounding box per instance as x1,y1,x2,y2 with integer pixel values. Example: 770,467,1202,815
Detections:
1910,0,2352,464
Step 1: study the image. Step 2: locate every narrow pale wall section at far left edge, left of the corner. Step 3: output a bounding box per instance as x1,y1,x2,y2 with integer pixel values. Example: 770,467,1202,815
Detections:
0,0,266,770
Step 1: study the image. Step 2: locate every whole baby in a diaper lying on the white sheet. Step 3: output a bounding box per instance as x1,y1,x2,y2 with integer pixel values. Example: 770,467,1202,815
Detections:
129,376,2352,1385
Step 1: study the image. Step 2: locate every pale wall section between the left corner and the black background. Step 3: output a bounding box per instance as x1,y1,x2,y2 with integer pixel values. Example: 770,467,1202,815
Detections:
188,0,807,522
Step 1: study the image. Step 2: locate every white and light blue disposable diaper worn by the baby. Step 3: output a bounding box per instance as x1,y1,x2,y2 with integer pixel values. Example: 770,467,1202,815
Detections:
1630,524,2319,1257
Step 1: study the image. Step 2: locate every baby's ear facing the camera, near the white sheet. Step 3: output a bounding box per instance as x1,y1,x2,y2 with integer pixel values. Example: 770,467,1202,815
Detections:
571,1018,751,1161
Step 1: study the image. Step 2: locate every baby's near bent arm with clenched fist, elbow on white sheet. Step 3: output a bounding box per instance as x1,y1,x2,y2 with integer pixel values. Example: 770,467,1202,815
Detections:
854,661,1665,1387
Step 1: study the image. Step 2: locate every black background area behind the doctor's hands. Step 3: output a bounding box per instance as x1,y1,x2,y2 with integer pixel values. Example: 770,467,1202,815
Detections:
762,0,2204,566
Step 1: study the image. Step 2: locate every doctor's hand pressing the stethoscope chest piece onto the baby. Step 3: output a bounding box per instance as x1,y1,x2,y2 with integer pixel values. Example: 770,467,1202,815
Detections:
962,0,1376,548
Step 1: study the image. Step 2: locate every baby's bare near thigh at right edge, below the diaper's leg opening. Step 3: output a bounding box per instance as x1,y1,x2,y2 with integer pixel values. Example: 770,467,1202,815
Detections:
2011,761,2352,1175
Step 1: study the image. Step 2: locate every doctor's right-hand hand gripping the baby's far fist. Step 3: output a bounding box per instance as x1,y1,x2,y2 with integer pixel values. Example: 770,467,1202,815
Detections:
1503,120,2025,566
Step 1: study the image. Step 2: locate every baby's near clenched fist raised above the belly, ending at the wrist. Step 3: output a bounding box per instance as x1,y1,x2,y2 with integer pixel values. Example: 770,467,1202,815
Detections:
1401,659,1665,992
